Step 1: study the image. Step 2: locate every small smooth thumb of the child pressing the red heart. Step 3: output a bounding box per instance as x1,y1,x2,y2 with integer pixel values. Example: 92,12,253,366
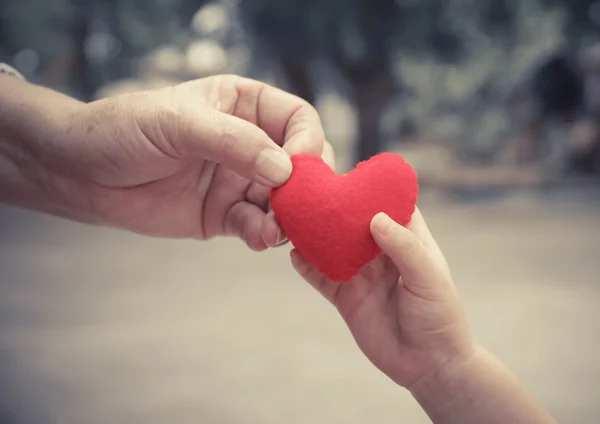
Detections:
371,213,447,300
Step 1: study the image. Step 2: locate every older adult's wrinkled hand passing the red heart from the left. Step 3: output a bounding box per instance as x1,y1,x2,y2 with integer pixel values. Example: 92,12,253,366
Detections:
1,75,333,250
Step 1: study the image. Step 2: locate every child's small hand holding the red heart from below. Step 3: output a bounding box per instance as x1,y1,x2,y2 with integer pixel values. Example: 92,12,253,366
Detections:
291,210,475,387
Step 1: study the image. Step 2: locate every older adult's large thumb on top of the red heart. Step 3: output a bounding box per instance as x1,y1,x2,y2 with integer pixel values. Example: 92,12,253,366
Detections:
179,108,292,187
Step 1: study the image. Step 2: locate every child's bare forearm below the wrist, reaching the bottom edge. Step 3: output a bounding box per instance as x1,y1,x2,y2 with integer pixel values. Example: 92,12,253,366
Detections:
411,348,556,424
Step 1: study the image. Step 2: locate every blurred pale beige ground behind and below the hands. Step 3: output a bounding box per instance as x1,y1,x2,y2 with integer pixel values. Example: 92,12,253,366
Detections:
0,192,600,424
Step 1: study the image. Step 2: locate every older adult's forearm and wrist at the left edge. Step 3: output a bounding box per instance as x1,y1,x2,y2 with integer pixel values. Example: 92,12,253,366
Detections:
0,74,86,216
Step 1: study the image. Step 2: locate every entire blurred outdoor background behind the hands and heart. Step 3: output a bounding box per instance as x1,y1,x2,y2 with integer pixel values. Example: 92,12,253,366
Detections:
0,0,600,424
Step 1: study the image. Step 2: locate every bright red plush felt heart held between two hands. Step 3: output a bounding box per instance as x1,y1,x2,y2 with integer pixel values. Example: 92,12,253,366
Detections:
270,153,418,282
